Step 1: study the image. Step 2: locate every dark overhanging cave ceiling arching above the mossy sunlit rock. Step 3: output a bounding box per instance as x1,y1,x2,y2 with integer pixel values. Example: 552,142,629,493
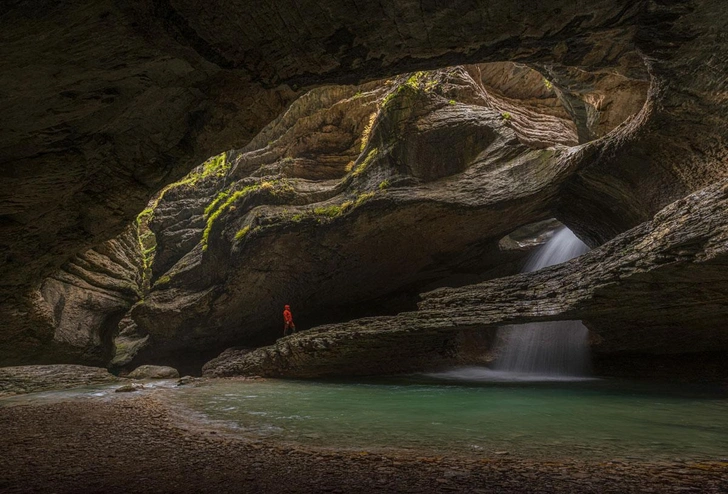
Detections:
0,0,728,366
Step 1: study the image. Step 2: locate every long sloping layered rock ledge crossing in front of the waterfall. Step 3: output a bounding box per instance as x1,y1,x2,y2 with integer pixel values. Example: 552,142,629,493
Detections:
207,181,728,377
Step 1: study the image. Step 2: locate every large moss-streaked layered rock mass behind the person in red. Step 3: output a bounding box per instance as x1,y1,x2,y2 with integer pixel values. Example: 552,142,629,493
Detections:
125,66,596,364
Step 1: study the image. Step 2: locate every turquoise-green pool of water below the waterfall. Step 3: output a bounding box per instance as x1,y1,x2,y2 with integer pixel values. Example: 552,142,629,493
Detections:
176,375,728,459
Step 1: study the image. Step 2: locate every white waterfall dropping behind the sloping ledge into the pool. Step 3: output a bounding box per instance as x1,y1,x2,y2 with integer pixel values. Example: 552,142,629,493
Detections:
495,227,589,376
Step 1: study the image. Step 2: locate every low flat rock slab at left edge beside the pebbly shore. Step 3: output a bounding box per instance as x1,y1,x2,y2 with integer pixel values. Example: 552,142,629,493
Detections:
0,365,122,396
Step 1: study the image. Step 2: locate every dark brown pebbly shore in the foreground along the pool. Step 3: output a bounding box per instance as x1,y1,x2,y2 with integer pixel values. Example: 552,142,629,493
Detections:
0,395,728,493
